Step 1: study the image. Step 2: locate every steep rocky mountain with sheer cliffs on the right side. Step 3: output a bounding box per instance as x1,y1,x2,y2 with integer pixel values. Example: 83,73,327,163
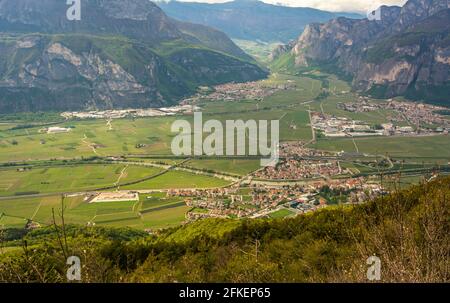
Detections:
272,0,450,105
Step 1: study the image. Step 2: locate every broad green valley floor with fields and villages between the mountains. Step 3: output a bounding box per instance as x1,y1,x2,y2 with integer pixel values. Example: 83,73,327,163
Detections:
0,71,450,232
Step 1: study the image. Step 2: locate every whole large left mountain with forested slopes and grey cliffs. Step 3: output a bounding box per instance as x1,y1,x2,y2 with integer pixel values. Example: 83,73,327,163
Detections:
0,0,267,113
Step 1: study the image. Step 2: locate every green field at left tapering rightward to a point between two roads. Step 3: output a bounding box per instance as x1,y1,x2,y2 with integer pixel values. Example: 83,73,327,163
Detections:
0,164,161,196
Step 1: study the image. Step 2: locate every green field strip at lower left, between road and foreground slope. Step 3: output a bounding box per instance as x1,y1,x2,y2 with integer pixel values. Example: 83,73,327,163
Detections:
0,193,190,229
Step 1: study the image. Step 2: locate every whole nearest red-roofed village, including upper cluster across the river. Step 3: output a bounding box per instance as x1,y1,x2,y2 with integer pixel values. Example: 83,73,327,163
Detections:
167,137,385,222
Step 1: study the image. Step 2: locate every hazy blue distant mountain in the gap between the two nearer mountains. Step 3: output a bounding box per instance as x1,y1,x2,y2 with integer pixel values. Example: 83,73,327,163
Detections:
158,0,361,43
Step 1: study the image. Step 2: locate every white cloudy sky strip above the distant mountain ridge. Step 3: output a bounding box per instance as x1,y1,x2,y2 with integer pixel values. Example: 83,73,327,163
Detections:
167,0,406,12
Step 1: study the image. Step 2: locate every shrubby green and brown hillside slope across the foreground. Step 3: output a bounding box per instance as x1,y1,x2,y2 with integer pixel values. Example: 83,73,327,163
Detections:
0,177,450,282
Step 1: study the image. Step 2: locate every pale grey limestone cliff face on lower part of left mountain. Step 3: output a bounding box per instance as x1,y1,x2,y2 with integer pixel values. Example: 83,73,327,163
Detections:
0,35,167,112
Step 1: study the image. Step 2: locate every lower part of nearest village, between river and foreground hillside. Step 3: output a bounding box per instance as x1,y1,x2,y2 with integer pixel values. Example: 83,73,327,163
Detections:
167,177,383,221
